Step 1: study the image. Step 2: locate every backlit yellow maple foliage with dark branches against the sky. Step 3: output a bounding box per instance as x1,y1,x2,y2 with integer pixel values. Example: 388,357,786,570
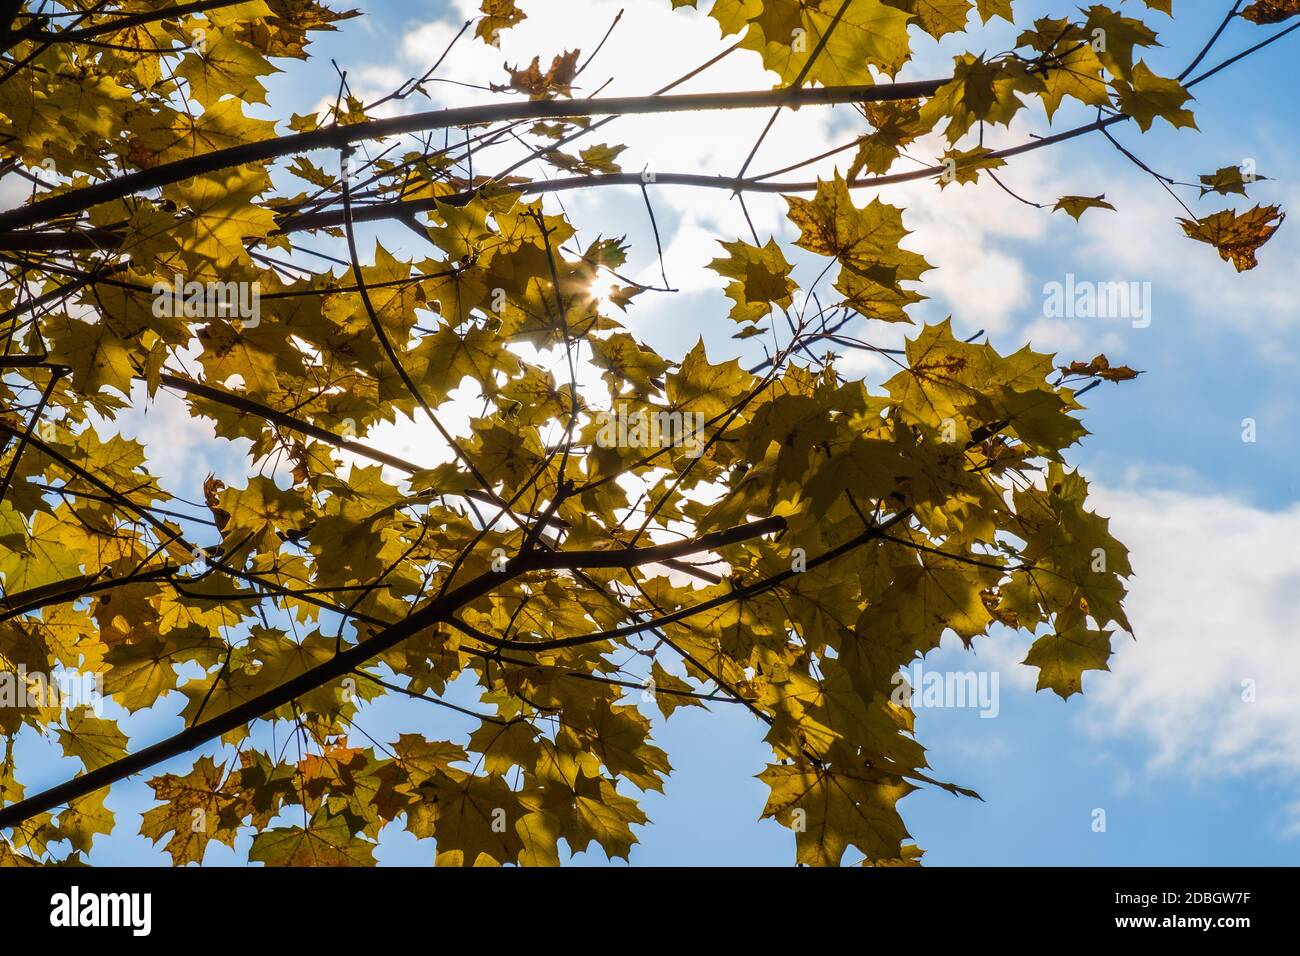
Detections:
0,0,1284,865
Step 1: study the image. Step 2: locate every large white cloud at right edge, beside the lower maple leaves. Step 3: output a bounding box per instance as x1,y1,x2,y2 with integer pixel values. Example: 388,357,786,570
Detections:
1086,489,1300,775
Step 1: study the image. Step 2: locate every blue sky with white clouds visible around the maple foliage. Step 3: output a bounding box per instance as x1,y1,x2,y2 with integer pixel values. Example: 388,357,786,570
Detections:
12,0,1300,865
